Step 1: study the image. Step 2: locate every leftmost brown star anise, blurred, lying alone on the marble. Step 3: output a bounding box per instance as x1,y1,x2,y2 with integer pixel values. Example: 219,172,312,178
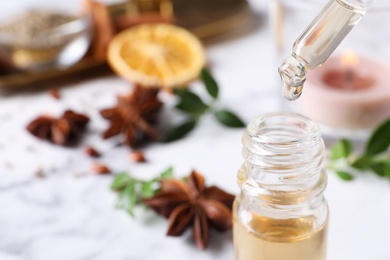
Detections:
27,110,89,145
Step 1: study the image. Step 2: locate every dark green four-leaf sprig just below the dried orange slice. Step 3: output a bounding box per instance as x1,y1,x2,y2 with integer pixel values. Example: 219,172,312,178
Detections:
162,68,245,142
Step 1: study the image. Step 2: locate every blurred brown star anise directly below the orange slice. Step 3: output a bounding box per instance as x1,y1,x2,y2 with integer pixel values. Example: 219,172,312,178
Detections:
100,86,162,147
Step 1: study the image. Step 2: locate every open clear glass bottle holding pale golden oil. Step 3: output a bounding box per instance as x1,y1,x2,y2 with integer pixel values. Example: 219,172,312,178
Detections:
233,113,328,260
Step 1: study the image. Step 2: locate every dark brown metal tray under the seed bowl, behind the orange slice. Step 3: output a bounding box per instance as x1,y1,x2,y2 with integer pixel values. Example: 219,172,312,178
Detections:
0,0,251,89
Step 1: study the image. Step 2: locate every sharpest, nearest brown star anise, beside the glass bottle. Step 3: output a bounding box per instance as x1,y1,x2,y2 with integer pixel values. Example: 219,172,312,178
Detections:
144,171,234,249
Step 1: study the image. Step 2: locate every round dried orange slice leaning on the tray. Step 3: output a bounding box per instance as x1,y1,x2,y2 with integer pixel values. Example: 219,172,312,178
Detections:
108,24,205,87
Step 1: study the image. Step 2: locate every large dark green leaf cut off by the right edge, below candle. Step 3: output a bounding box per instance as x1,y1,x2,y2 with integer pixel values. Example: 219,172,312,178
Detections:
365,119,390,155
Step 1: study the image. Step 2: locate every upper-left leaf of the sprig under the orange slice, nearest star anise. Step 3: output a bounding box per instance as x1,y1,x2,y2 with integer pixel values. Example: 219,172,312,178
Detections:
175,89,208,115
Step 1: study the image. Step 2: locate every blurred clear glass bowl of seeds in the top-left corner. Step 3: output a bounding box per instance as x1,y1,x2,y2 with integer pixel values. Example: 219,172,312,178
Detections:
0,0,92,71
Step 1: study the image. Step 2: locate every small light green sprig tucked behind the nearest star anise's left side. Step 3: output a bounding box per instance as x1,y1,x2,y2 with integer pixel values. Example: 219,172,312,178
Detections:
111,167,173,217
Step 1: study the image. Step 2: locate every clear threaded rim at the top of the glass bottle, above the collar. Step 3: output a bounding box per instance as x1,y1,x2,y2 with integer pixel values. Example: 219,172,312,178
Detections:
242,112,325,195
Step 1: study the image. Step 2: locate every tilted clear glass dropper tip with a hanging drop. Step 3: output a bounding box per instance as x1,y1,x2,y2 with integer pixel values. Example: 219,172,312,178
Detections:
279,0,376,100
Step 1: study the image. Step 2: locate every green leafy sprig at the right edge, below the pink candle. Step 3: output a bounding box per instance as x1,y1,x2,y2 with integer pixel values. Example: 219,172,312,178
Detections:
328,119,390,181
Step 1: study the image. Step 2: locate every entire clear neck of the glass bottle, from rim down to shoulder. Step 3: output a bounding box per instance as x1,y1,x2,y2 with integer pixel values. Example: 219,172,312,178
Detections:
239,113,327,211
